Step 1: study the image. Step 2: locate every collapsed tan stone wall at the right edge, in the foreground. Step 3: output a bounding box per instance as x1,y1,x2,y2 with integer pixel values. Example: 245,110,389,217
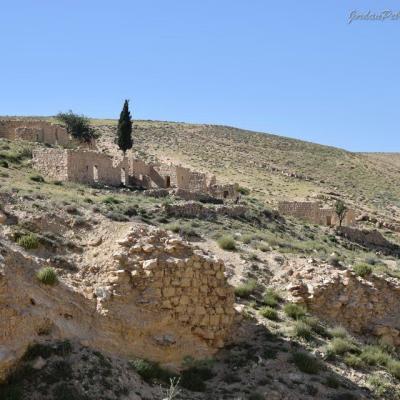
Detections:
289,268,400,346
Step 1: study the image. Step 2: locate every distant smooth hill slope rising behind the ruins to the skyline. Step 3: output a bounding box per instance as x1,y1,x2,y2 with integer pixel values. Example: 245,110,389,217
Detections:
3,118,400,220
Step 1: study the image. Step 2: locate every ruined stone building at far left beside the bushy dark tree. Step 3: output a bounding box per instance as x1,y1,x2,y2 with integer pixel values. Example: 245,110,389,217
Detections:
0,119,74,146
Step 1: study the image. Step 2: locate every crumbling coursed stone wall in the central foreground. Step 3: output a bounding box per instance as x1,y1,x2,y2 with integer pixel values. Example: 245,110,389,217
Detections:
114,228,234,347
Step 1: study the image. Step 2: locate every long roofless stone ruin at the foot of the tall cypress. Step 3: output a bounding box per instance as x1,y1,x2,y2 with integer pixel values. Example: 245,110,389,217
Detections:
32,148,238,199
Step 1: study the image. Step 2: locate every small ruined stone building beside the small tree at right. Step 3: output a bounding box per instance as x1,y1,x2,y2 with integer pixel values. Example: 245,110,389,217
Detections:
278,201,356,226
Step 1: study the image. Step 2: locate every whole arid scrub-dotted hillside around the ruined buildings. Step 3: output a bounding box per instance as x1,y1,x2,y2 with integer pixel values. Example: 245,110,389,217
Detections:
0,120,400,400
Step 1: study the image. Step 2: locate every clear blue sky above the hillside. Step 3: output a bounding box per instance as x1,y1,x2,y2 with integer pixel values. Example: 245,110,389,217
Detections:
0,0,400,152
